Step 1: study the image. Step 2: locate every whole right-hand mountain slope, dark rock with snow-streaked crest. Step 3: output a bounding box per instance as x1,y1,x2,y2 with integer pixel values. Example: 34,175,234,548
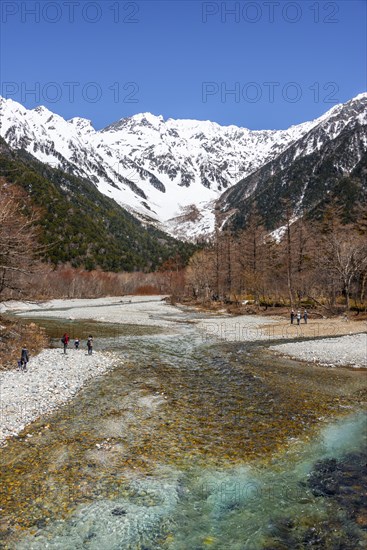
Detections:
217,94,367,230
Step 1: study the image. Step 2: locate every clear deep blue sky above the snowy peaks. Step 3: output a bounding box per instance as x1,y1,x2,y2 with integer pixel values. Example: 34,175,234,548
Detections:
0,0,367,129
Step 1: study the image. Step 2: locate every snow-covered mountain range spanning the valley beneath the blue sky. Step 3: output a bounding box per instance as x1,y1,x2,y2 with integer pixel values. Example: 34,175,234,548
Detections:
0,94,367,238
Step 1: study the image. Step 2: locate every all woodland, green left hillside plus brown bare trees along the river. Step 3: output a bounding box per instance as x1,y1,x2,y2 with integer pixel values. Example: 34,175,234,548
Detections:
0,138,367,313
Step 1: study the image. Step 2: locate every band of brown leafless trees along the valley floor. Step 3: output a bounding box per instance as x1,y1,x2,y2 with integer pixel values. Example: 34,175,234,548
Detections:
0,171,367,313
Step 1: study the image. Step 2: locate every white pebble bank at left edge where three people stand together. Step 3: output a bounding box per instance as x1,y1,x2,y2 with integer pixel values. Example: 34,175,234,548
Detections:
0,349,115,444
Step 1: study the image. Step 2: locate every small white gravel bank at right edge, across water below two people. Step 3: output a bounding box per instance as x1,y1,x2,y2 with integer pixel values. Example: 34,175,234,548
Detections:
269,334,367,368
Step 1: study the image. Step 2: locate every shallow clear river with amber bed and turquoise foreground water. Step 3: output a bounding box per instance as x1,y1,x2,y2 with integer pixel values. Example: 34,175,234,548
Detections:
0,306,367,550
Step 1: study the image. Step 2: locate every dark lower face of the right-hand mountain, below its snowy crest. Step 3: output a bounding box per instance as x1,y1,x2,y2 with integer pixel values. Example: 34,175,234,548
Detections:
217,122,367,231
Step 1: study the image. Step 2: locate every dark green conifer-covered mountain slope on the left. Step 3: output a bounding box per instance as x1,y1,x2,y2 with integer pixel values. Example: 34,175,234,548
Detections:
0,137,196,272
